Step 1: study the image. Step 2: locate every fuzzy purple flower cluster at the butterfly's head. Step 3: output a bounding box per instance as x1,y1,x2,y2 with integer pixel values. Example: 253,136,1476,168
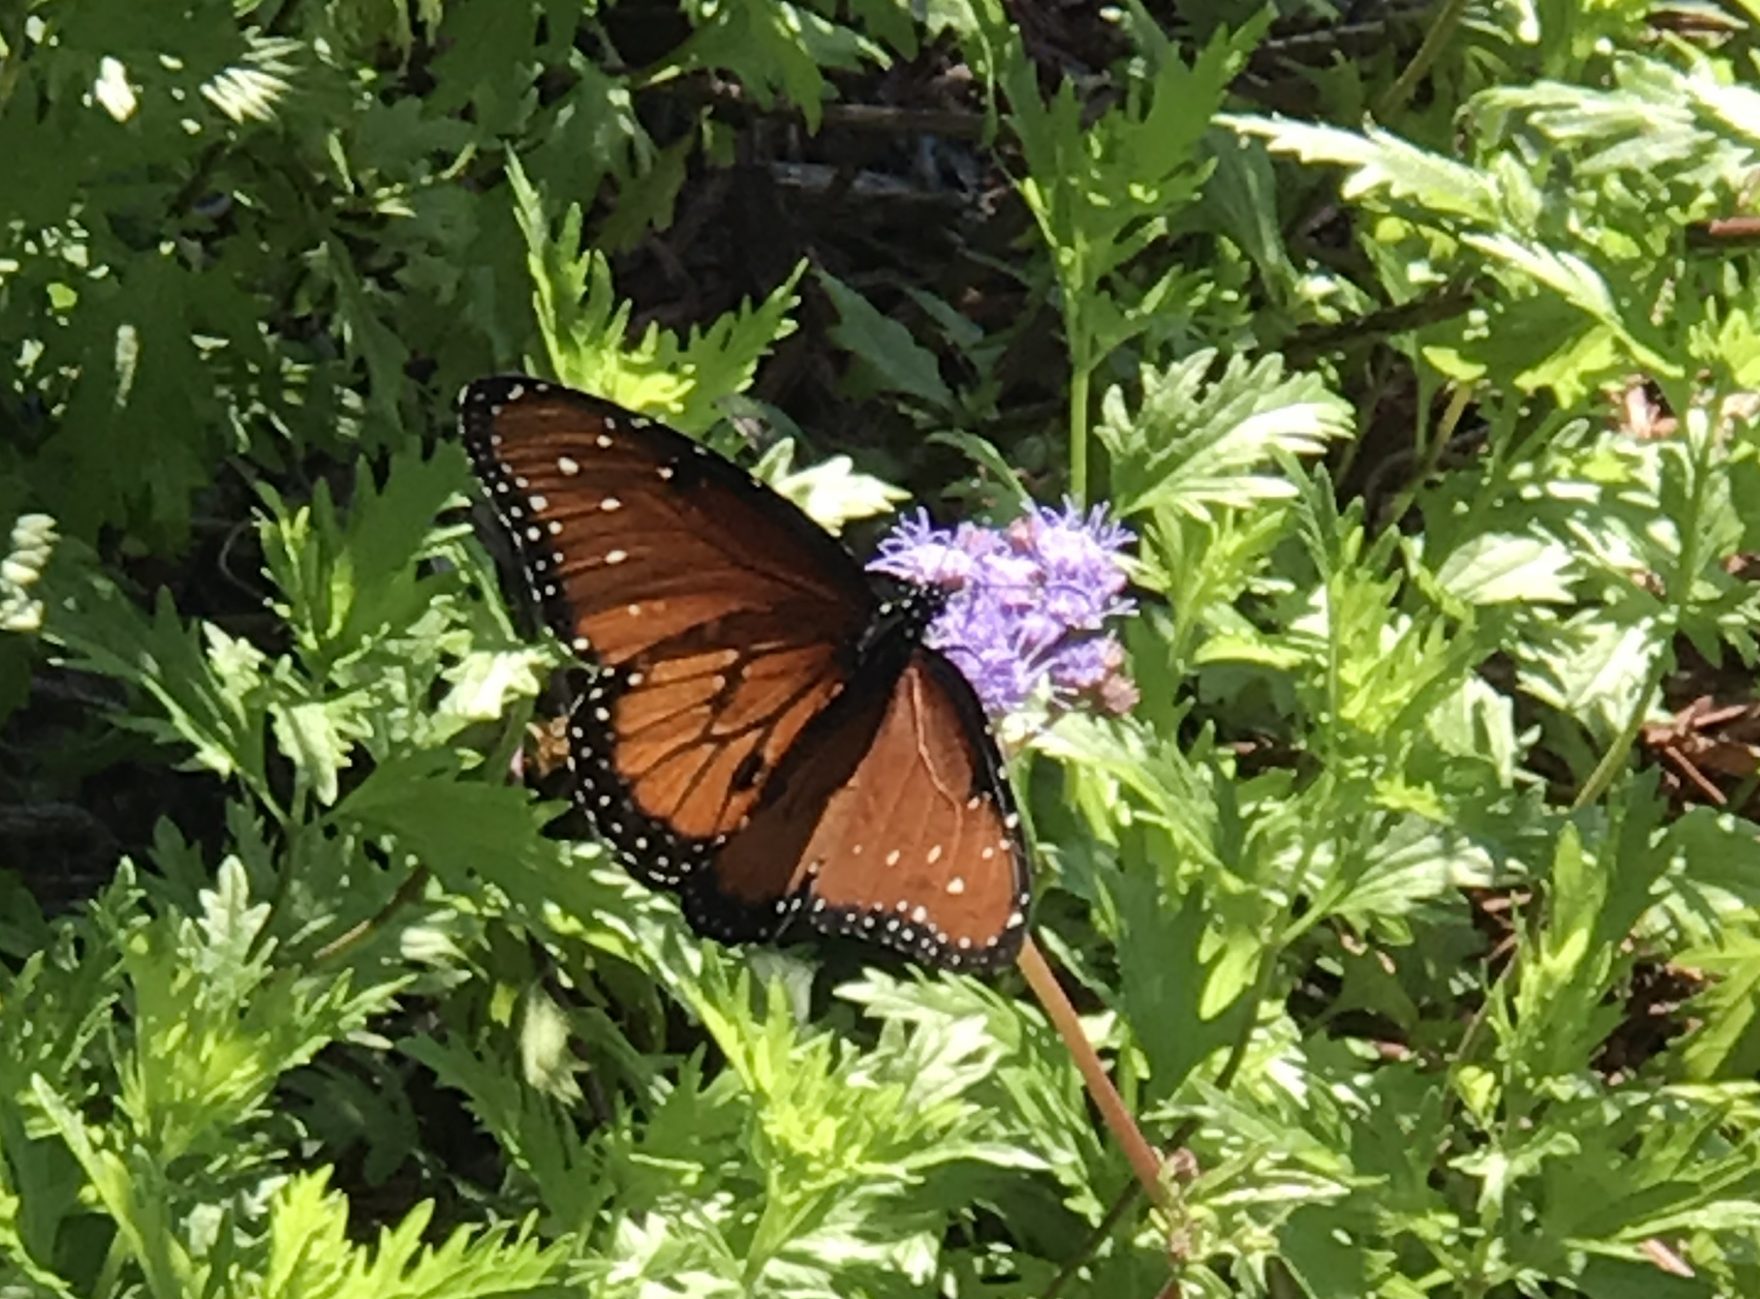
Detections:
868,502,1137,716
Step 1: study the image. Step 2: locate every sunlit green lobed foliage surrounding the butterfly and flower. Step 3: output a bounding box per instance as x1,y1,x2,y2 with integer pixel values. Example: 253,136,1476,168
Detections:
0,0,1760,1299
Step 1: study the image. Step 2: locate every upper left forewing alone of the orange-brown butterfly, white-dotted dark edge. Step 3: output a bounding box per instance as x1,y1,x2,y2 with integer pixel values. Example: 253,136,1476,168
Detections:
459,377,873,667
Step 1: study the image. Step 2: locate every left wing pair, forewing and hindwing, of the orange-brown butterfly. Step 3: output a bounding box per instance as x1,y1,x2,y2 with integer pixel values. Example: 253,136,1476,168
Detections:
459,377,875,869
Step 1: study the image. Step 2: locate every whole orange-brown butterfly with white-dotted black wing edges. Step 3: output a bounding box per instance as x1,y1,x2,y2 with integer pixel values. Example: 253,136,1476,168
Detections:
458,375,1030,970
